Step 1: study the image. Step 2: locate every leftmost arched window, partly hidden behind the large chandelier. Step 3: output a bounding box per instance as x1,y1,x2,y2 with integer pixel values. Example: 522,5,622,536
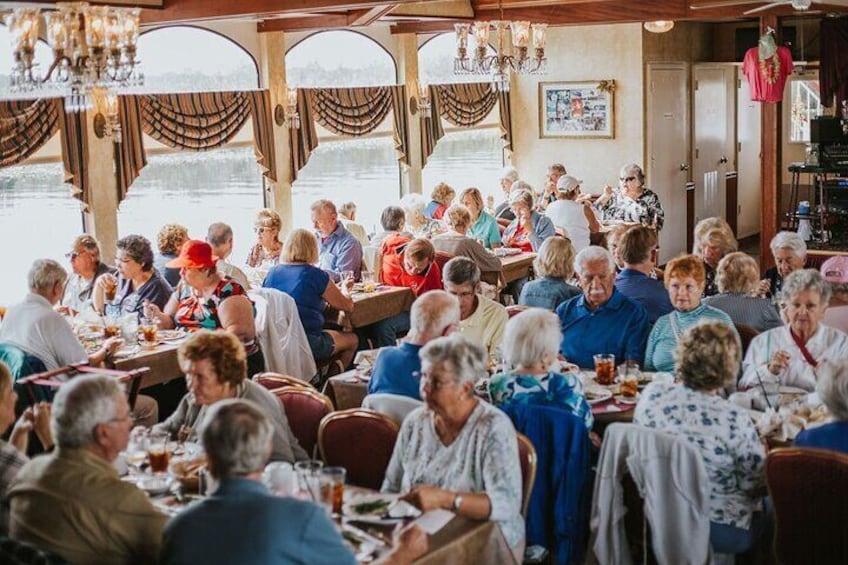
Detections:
0,25,82,306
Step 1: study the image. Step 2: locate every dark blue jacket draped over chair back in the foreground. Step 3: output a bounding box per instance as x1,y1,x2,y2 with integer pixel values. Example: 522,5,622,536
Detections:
503,403,592,565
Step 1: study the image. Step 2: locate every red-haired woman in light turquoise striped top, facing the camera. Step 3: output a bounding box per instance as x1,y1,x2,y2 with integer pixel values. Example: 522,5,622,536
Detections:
645,255,736,372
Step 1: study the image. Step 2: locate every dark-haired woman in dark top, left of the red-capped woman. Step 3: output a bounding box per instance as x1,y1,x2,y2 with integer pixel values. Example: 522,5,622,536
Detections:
92,235,173,315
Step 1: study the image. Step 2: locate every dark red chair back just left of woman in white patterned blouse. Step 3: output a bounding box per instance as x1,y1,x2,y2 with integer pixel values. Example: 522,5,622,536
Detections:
318,408,399,489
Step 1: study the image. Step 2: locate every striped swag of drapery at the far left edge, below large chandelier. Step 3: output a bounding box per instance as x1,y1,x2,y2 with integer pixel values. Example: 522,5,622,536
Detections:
0,98,62,167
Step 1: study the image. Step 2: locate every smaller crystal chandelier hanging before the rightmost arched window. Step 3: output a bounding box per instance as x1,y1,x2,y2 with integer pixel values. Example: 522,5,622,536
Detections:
453,2,548,92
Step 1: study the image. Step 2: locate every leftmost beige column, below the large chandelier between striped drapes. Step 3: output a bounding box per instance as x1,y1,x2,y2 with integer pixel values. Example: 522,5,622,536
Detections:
82,114,118,265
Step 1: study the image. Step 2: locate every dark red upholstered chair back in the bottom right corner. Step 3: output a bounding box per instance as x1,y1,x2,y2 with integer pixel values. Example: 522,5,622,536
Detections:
766,448,848,563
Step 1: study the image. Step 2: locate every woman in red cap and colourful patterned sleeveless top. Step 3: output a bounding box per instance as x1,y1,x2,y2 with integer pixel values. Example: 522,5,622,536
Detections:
144,240,265,375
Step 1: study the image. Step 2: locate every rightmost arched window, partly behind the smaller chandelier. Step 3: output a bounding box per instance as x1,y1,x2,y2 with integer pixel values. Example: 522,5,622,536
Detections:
418,33,503,202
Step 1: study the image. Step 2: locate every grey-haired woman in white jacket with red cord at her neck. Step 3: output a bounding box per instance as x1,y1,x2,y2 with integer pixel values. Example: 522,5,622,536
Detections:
739,269,848,392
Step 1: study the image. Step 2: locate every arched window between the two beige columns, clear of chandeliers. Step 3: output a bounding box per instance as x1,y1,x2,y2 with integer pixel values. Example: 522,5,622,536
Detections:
286,31,400,231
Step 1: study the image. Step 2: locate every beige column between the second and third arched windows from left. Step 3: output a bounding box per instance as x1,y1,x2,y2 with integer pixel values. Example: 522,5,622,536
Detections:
259,31,294,237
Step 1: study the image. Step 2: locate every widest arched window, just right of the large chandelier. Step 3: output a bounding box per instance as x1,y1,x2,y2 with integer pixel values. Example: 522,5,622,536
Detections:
118,26,264,264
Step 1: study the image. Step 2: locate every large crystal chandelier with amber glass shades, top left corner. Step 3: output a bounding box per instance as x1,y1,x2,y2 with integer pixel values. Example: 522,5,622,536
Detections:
6,2,144,112
